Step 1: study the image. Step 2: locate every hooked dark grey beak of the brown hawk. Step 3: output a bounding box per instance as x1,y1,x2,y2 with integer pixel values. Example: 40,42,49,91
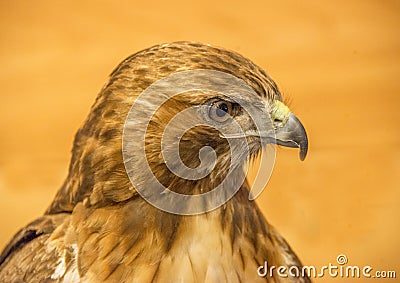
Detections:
275,113,308,161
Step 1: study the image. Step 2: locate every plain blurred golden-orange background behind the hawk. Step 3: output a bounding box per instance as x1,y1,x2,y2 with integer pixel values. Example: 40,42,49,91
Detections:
0,0,400,282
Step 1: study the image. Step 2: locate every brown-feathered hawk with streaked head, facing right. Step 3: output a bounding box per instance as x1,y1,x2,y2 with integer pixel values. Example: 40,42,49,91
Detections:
0,42,310,282
